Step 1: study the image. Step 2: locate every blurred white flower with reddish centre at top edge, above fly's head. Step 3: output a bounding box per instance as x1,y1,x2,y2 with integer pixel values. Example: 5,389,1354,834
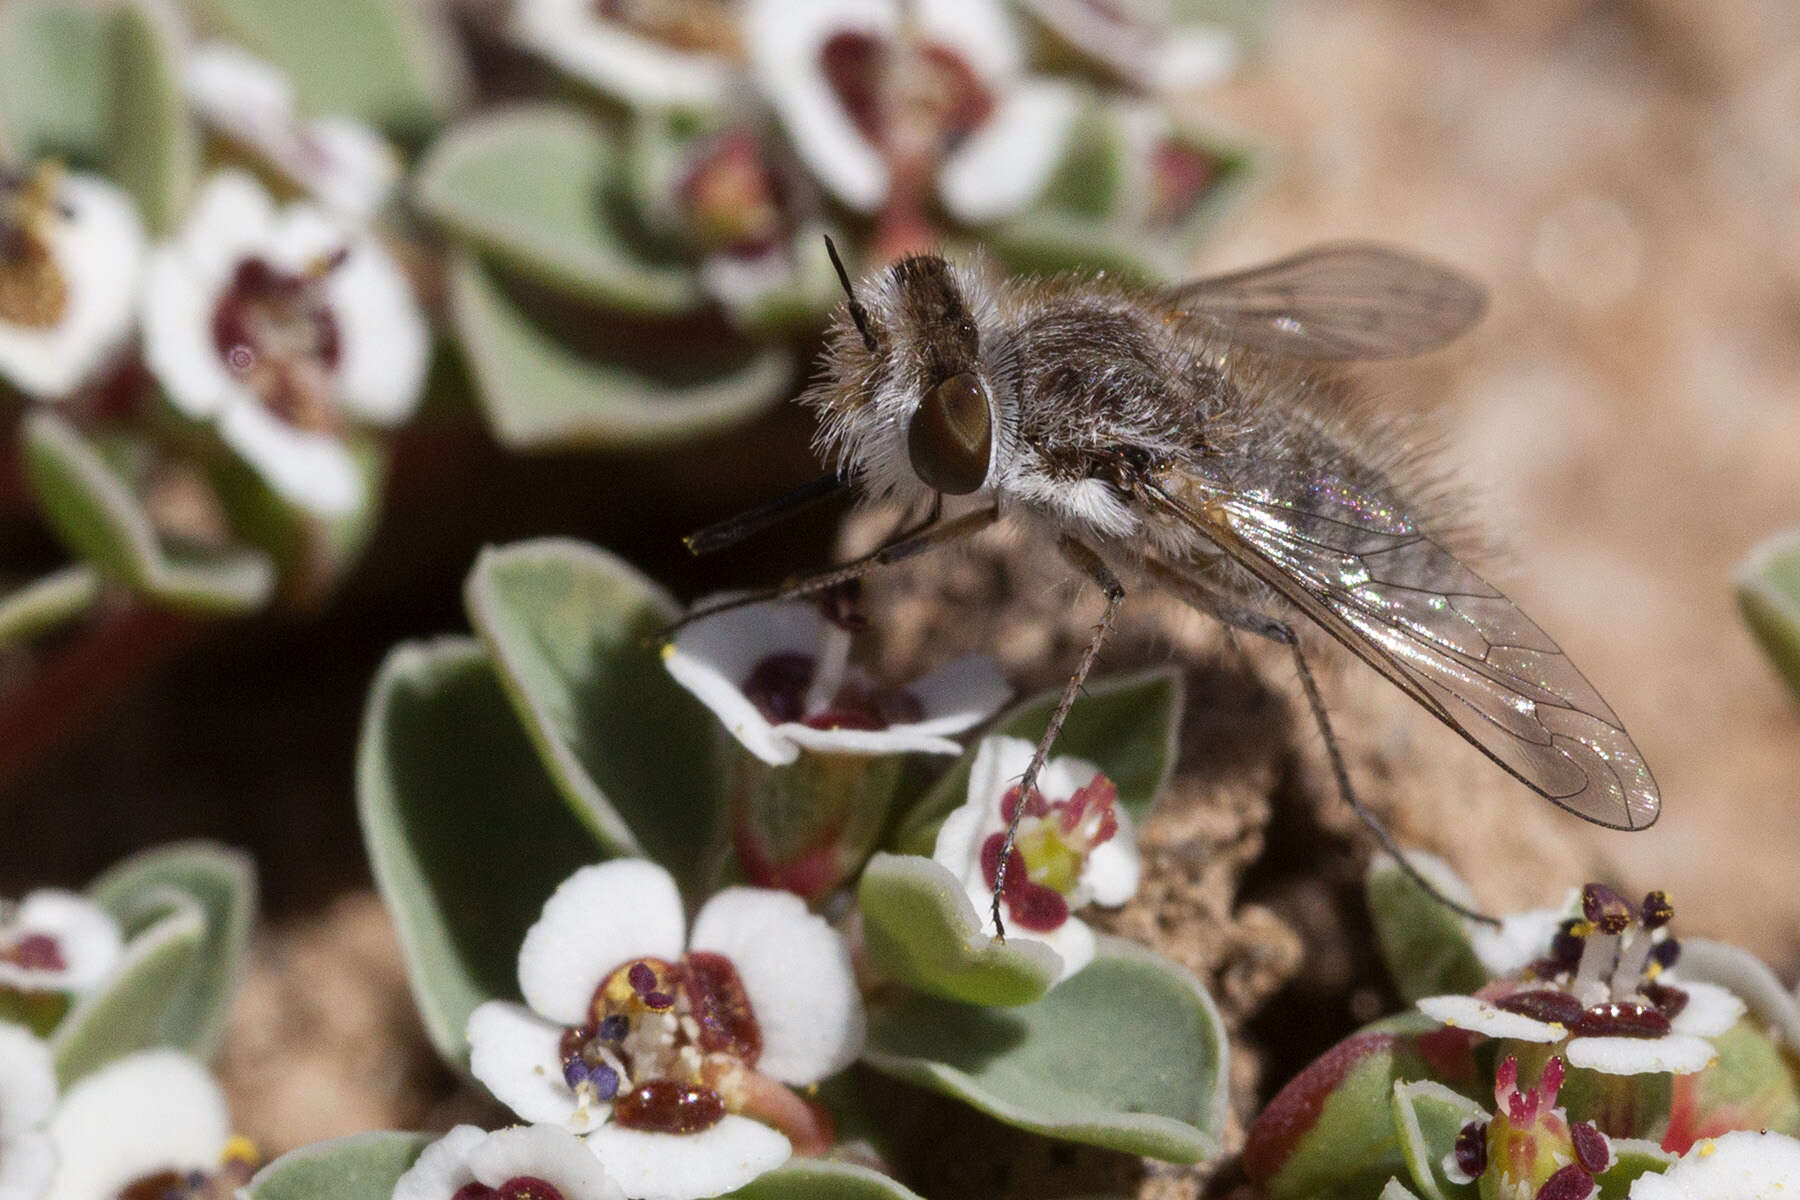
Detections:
743,0,1080,223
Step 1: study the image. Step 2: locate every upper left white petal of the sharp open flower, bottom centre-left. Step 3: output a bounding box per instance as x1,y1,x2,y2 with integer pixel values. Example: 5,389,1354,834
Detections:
518,858,688,1025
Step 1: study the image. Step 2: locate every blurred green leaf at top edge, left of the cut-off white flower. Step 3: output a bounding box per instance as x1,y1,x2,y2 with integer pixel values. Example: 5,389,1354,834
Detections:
189,0,464,144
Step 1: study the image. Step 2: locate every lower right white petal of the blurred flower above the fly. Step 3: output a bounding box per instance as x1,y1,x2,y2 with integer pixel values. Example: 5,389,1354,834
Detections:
938,79,1082,225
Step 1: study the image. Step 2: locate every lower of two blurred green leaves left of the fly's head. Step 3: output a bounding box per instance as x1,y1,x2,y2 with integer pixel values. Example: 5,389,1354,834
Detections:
450,257,792,450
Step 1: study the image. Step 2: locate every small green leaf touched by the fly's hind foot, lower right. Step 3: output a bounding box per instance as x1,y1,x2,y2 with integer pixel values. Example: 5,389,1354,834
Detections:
1363,853,1487,1007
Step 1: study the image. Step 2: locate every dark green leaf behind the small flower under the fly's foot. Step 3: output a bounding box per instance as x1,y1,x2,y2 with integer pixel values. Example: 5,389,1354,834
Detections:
896,667,1183,856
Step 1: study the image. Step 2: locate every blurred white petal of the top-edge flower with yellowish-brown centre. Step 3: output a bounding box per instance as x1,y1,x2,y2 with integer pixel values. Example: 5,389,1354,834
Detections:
509,0,733,108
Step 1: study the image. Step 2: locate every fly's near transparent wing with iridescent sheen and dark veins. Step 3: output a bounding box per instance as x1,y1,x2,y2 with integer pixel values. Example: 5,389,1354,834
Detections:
1152,464,1661,829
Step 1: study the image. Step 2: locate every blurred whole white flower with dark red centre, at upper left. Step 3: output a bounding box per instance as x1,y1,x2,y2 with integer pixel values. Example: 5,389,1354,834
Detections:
144,171,430,516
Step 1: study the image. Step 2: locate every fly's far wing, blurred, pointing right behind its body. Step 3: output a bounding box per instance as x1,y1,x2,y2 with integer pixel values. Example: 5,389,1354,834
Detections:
1161,243,1487,360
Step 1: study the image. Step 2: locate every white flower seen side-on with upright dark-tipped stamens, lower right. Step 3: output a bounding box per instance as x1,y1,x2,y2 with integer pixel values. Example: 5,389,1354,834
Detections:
1418,883,1746,1076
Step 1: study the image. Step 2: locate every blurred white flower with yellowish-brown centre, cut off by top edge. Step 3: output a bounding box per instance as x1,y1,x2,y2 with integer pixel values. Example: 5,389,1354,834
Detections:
509,0,740,108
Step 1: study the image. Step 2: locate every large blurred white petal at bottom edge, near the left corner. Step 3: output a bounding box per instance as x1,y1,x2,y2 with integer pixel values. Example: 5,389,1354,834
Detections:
47,1051,230,1200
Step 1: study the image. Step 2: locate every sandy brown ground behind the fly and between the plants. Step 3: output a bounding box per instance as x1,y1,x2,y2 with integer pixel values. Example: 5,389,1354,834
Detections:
189,0,1800,1195
